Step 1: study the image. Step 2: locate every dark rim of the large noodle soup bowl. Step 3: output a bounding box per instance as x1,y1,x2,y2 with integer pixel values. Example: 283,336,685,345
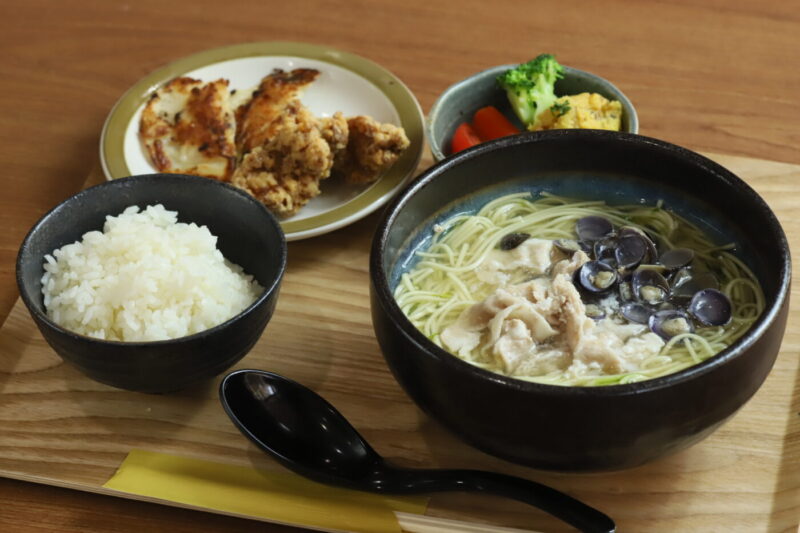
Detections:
370,130,791,397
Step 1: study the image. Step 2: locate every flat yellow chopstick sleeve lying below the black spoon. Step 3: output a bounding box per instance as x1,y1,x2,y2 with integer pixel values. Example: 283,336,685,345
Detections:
103,450,427,533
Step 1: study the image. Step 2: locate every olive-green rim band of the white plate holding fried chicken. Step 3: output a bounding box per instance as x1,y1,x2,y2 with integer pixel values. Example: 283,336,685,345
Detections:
100,42,424,240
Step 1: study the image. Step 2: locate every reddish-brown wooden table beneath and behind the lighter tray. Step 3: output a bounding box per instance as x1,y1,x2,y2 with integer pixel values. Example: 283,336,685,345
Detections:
0,0,800,532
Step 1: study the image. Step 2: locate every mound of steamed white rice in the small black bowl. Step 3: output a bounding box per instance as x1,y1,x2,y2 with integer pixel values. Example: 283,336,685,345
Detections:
42,205,264,342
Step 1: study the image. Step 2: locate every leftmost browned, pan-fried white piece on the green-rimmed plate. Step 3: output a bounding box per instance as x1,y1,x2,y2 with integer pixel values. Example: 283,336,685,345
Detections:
139,77,236,181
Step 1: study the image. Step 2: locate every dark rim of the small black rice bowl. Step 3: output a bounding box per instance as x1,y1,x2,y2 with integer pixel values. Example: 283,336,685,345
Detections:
16,173,288,349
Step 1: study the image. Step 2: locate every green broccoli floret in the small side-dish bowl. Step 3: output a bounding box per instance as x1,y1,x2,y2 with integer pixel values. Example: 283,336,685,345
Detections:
497,54,564,129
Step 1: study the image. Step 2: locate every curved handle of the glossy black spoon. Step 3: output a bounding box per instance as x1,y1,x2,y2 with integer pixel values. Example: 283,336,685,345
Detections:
392,469,616,533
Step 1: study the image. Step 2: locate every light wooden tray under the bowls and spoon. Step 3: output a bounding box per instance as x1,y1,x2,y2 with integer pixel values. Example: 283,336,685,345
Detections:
0,155,800,533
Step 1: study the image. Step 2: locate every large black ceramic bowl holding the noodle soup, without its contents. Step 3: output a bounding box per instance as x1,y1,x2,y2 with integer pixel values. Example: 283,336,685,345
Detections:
370,130,791,471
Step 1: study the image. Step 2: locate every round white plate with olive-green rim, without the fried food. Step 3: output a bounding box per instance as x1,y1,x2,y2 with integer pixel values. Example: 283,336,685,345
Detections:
100,43,424,241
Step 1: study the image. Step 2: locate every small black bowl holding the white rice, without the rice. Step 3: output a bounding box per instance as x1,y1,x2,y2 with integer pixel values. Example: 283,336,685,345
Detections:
17,174,286,393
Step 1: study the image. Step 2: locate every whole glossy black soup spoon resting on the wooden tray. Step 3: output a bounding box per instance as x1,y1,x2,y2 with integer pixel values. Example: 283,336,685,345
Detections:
220,370,616,533
